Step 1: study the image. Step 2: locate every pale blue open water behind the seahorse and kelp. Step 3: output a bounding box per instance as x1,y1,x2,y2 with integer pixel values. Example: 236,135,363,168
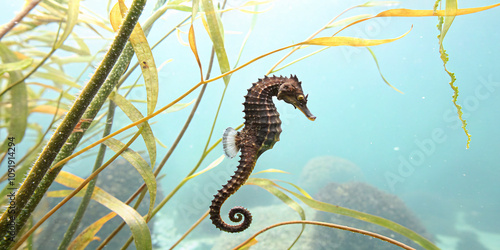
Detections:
2,0,500,249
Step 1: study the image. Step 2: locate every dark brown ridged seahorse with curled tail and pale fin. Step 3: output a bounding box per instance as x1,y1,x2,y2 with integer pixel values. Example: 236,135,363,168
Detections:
210,75,316,233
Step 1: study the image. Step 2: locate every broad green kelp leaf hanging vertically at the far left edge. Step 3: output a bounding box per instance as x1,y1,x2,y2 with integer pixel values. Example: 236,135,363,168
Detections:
0,43,28,152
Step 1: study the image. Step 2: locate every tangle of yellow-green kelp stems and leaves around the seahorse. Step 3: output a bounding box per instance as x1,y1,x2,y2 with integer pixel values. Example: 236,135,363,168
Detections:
0,0,500,249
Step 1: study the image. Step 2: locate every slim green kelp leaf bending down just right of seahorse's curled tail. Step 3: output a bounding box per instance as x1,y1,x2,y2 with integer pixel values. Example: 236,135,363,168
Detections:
246,178,306,248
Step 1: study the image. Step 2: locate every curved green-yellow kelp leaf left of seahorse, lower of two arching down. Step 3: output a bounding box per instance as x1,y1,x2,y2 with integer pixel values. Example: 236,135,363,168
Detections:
103,138,156,220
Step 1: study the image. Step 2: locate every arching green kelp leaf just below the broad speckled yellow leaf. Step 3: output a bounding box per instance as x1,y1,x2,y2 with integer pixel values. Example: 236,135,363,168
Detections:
109,91,156,170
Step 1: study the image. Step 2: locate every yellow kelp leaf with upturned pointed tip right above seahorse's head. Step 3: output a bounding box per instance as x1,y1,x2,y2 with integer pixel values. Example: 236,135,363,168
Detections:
298,26,411,47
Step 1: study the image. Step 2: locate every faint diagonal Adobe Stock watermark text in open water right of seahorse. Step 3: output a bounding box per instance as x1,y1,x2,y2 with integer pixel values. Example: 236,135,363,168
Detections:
384,75,500,192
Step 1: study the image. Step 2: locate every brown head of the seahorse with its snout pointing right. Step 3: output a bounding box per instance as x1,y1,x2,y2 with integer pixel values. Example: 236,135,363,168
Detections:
277,75,316,121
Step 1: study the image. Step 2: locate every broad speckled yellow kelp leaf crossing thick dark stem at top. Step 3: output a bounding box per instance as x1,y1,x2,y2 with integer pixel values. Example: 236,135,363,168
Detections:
110,0,158,115
